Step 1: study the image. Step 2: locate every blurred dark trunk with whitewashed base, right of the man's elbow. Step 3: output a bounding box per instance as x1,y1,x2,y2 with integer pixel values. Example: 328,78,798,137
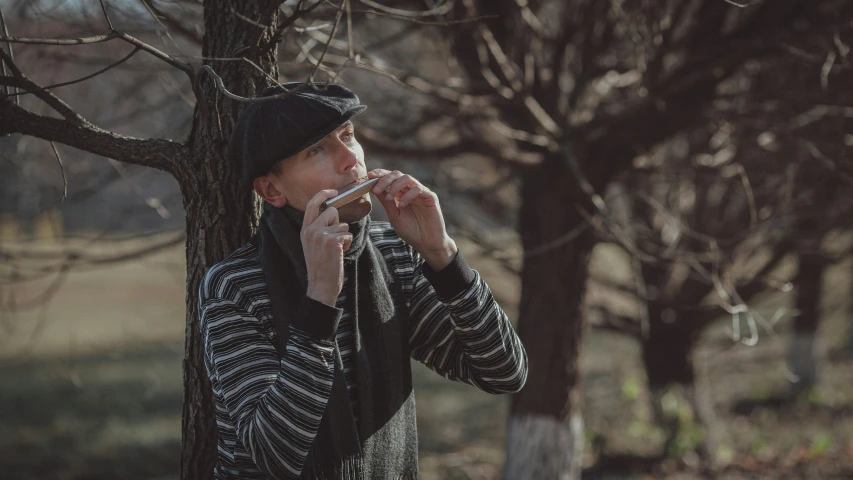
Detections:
504,156,594,480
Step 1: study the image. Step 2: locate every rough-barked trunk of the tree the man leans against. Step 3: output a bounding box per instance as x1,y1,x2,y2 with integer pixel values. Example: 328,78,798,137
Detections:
176,0,280,479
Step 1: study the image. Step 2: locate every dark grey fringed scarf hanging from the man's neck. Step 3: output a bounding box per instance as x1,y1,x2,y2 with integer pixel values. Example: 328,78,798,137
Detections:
255,202,417,480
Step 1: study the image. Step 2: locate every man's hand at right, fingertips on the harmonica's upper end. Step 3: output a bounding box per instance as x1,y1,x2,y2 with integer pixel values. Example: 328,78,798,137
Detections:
367,168,457,271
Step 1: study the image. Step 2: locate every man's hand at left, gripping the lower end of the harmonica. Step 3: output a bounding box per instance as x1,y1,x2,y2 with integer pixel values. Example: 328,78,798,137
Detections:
300,190,352,307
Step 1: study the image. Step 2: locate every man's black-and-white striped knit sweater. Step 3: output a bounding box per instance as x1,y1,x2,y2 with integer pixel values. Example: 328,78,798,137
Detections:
199,222,527,479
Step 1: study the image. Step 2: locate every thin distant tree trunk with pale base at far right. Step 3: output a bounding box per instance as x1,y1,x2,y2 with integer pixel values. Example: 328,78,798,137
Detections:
787,253,826,395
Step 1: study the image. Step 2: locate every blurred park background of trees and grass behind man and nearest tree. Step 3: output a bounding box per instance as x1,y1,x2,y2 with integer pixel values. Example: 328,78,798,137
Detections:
5,0,853,479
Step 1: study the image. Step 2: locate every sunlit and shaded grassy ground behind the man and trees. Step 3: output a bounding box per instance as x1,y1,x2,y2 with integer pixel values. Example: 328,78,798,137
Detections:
0,235,853,480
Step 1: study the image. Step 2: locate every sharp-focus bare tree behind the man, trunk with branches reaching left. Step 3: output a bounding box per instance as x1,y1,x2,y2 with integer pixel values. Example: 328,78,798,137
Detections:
0,1,304,478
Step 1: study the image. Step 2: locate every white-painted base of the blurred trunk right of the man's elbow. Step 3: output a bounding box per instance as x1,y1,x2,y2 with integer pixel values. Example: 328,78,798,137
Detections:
503,415,584,480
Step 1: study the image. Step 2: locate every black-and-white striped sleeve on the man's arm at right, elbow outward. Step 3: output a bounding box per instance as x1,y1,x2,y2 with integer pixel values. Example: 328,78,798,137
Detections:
409,249,527,393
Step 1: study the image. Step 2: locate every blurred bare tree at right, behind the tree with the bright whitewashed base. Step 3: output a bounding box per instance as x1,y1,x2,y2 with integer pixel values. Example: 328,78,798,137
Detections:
594,25,853,454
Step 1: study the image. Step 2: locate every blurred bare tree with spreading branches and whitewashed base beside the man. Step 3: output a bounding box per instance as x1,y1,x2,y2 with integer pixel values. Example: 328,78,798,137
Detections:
342,0,851,479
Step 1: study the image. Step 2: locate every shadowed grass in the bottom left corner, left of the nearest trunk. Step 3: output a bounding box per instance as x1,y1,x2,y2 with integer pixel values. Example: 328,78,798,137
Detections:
0,347,182,480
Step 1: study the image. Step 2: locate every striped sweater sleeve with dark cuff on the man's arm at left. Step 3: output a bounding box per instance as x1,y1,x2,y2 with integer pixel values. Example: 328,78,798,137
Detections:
200,297,340,479
